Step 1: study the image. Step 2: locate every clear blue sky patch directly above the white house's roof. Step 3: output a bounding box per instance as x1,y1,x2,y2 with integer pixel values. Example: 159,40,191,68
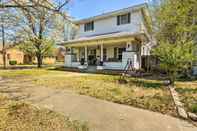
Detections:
68,0,145,19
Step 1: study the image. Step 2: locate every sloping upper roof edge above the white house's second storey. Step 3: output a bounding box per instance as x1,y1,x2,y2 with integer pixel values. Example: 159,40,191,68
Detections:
73,3,148,24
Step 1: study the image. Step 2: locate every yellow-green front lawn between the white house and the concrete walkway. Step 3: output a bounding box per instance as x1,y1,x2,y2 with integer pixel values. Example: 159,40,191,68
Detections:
0,69,176,116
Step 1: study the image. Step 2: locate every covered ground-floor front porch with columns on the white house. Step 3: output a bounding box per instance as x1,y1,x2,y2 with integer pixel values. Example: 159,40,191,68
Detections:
65,33,149,70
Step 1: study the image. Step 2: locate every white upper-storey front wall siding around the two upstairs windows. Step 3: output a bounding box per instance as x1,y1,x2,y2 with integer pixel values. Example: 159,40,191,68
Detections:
77,11,143,38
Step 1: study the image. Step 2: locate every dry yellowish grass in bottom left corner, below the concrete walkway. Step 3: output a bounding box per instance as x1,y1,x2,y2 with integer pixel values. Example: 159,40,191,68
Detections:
0,96,89,131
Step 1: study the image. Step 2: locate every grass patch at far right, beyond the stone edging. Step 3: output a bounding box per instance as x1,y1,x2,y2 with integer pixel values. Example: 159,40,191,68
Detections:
176,81,197,114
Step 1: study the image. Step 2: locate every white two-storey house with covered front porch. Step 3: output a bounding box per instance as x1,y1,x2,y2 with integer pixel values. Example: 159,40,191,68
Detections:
64,4,153,70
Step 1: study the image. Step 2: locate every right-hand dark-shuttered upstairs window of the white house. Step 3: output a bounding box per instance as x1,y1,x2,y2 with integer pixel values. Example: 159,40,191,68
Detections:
117,13,131,25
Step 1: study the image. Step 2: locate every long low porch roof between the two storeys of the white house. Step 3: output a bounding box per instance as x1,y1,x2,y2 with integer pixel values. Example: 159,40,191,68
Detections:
63,32,146,46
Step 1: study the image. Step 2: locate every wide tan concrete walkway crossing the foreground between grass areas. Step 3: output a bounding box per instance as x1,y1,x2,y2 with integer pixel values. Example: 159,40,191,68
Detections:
0,78,197,131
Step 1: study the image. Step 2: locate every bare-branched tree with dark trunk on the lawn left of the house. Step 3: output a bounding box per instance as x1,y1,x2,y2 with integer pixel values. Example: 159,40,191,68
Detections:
17,0,70,68
